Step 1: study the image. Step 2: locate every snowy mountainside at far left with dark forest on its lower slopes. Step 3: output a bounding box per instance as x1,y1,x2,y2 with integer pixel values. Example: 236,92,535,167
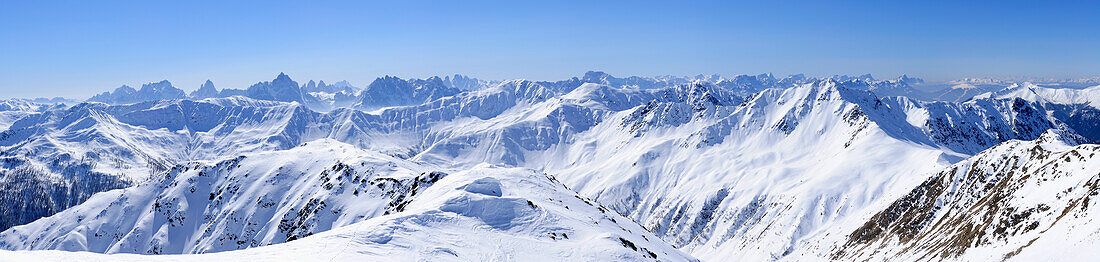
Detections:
0,98,334,229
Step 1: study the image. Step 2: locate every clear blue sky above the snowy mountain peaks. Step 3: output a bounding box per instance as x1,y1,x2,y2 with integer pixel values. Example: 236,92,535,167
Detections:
0,0,1100,98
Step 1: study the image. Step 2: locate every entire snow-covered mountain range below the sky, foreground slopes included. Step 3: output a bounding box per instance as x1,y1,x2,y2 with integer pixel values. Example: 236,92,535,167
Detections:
0,72,1100,261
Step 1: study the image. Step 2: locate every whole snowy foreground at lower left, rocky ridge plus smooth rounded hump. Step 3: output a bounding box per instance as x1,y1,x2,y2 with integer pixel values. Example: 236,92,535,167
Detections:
0,140,690,261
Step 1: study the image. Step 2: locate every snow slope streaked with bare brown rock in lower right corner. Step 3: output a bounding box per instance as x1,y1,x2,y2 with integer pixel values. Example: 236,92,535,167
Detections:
829,131,1100,261
